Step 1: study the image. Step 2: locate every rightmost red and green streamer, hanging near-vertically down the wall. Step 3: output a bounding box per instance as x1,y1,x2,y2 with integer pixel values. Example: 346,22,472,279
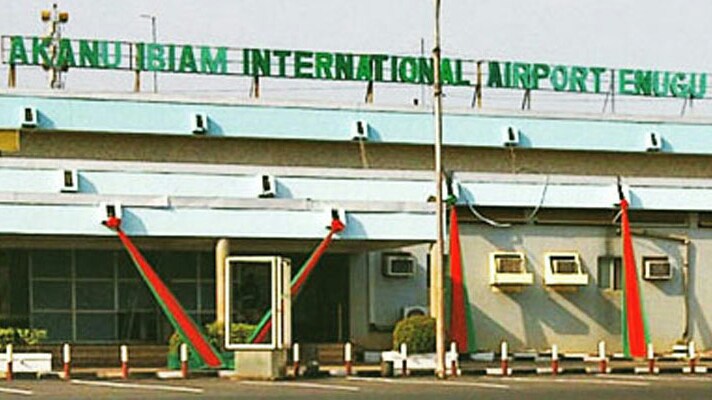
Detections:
620,198,650,358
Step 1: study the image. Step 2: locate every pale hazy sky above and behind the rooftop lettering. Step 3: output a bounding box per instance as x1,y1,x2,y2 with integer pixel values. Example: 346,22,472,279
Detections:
0,0,712,116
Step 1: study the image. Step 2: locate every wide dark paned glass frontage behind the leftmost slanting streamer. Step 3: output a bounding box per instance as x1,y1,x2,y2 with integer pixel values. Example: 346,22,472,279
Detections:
25,250,215,343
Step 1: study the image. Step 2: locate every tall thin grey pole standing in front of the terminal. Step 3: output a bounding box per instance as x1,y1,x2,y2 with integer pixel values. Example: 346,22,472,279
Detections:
431,0,446,379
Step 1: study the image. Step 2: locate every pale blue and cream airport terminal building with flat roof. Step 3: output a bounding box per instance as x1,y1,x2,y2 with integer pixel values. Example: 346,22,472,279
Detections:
0,86,712,352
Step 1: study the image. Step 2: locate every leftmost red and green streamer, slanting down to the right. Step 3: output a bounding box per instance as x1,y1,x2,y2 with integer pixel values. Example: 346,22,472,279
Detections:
104,217,223,368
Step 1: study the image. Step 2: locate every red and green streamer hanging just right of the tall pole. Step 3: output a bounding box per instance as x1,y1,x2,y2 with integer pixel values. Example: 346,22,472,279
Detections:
449,207,477,353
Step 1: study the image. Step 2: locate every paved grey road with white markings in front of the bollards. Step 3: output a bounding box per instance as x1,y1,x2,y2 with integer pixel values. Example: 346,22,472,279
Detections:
0,375,712,400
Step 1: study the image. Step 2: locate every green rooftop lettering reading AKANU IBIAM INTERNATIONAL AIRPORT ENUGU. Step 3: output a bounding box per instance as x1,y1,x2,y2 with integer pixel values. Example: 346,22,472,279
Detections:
0,36,707,99
